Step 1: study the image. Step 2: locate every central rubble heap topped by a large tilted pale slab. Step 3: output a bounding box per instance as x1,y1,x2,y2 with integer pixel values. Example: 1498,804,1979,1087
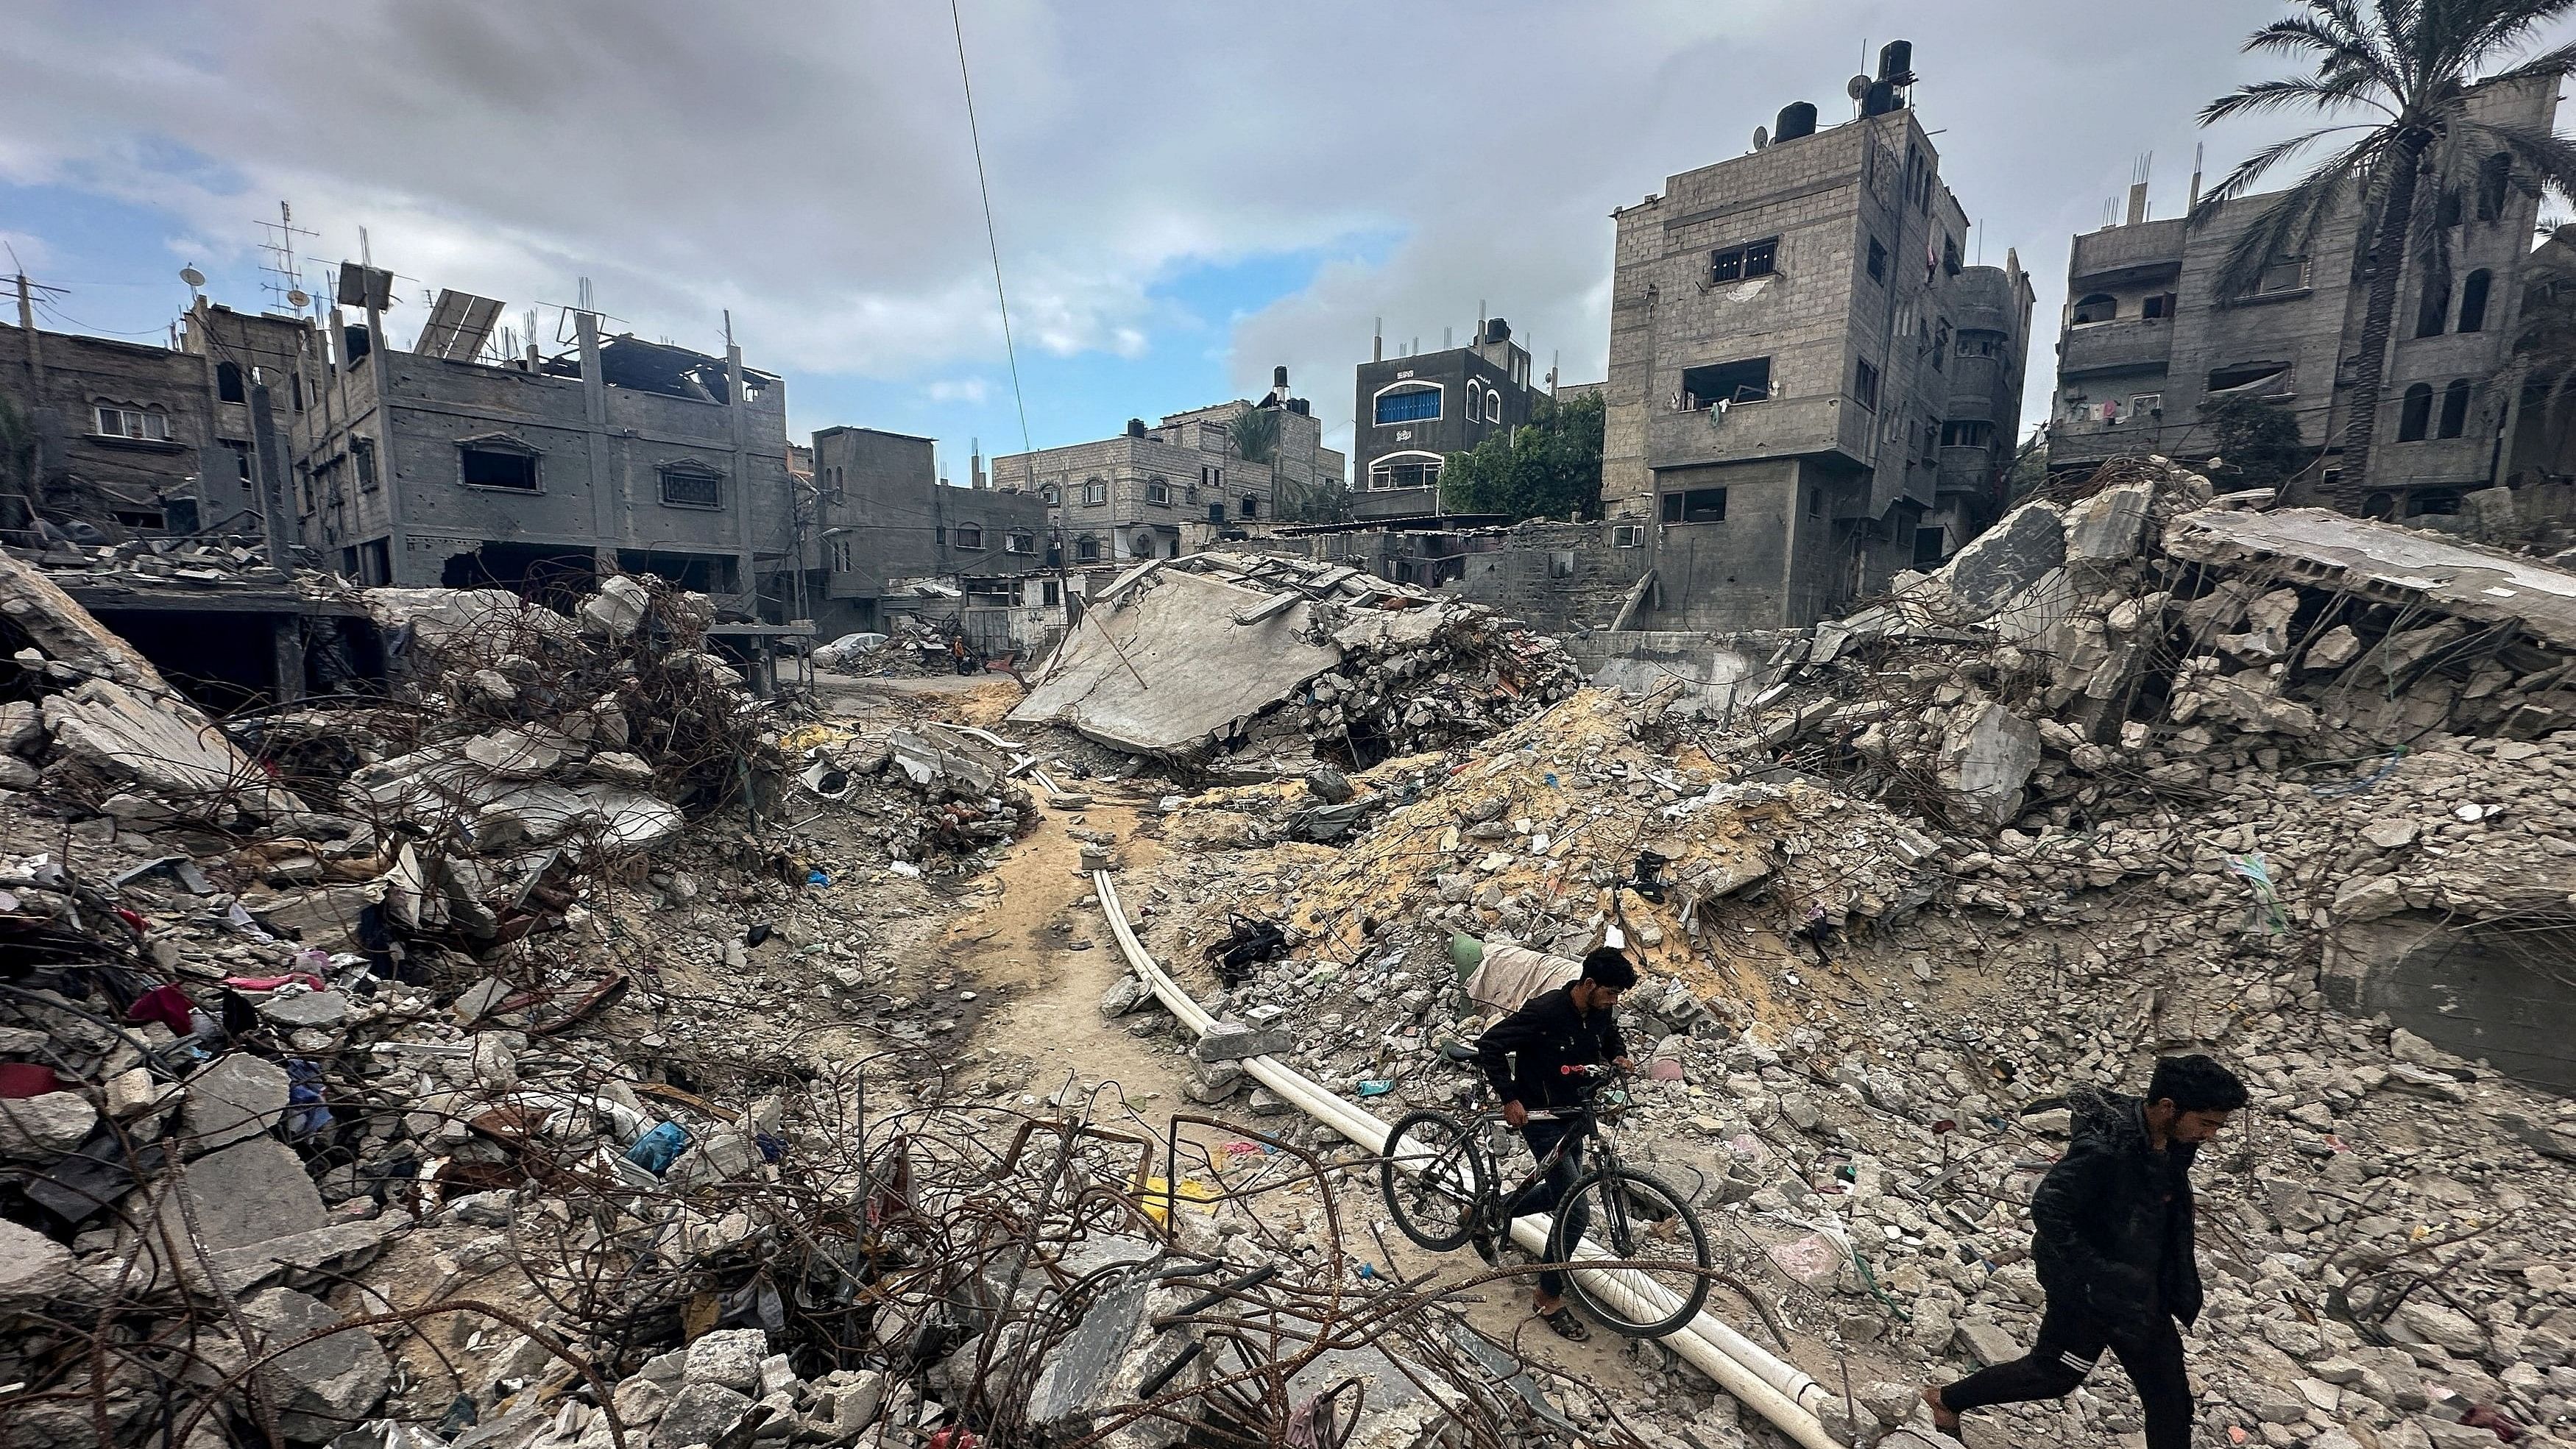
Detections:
1010,553,1582,772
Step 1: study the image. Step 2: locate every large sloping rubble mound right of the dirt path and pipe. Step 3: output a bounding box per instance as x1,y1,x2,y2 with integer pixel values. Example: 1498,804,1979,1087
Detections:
1103,461,2576,1449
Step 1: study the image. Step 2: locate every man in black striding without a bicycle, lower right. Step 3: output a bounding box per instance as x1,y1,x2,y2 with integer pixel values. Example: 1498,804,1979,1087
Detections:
1925,1055,2246,1449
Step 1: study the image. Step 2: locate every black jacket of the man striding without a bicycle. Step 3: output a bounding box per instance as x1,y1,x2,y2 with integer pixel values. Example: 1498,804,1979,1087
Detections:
2030,1088,2200,1328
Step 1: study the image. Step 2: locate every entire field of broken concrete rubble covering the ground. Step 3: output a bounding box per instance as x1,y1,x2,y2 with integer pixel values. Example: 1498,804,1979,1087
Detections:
15,461,2576,1449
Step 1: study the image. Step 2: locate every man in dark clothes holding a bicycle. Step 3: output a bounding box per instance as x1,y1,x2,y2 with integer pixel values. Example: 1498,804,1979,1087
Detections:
1476,947,1636,1344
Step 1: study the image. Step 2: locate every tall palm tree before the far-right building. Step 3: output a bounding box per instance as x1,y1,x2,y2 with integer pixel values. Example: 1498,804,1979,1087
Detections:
2193,0,2576,512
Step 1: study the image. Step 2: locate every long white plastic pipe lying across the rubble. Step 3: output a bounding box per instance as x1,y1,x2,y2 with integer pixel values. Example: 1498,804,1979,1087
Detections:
1092,870,1865,1449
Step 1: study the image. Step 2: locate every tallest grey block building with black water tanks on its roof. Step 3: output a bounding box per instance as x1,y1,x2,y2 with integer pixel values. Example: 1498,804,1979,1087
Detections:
1602,41,2033,631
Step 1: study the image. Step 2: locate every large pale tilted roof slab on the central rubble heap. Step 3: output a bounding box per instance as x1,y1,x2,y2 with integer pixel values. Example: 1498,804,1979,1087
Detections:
1010,569,1342,754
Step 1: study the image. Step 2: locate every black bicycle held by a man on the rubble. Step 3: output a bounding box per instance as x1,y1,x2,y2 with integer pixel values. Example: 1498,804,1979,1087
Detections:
1379,1066,1710,1339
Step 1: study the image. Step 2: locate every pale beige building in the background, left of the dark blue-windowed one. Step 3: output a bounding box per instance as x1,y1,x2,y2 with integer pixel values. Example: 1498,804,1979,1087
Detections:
992,368,1342,569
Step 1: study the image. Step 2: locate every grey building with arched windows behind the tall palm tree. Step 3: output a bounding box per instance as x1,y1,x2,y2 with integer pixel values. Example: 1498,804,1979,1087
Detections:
2048,79,2558,517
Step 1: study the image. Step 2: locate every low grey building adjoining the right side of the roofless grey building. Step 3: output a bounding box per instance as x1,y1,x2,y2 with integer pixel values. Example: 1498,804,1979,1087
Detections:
804,428,1064,643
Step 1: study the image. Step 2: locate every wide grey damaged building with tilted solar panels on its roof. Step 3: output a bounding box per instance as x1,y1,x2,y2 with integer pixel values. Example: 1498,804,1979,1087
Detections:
294,280,796,623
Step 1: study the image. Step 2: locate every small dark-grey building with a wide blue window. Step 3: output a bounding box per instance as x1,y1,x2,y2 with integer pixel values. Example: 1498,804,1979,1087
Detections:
1350,316,1540,520
